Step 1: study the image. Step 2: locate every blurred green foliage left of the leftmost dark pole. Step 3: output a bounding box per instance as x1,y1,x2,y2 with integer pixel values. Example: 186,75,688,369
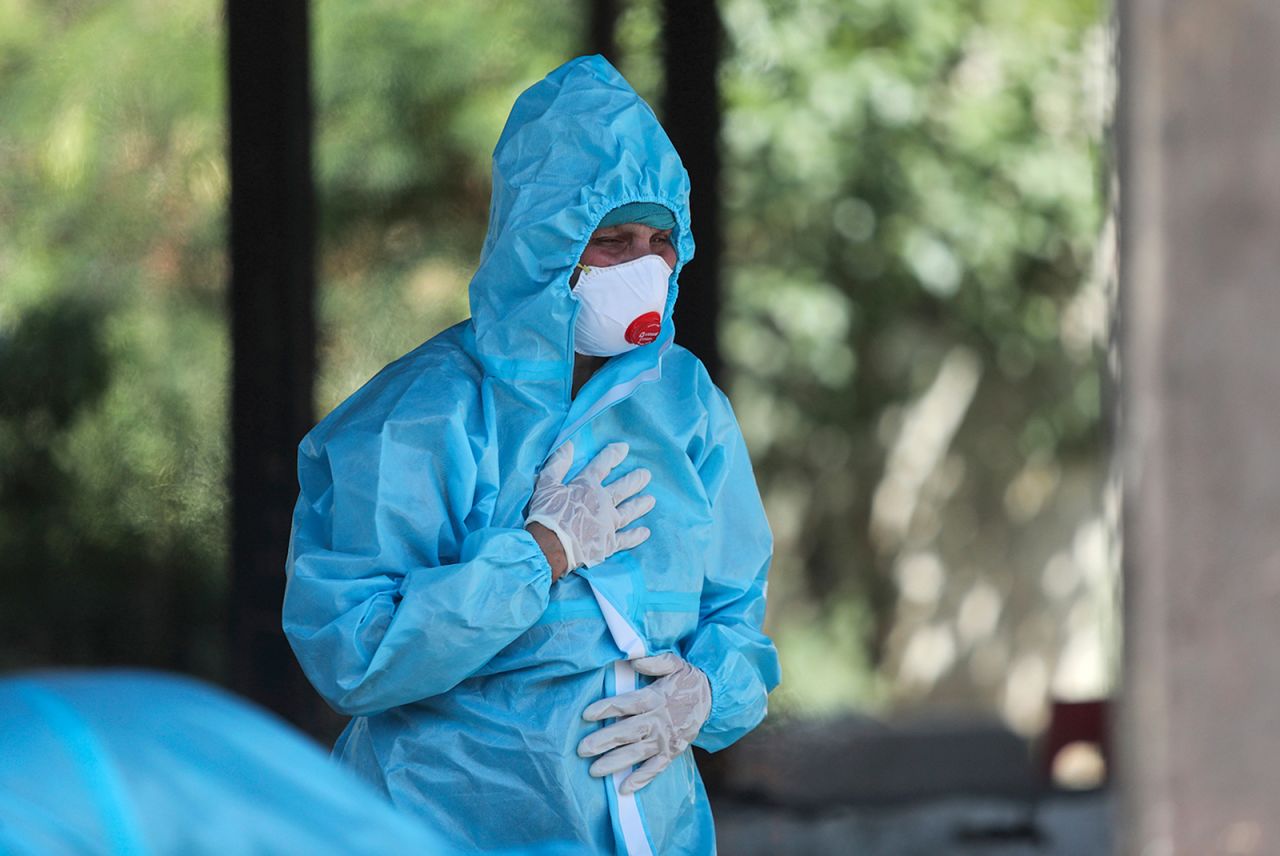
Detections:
0,1,227,674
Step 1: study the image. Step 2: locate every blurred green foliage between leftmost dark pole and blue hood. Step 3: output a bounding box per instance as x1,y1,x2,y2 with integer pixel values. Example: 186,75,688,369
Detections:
314,0,586,413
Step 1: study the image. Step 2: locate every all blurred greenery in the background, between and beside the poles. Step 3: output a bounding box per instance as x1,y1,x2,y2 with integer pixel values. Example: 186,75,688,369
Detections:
0,0,1119,733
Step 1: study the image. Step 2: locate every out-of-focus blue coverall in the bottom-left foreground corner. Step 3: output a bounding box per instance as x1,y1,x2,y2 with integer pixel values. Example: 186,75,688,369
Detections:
0,670,552,856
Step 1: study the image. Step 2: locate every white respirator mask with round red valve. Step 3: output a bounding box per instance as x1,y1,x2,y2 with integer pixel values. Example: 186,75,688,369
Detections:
573,255,671,357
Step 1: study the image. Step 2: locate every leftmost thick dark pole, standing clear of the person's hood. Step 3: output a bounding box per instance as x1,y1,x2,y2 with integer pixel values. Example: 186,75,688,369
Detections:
227,0,316,725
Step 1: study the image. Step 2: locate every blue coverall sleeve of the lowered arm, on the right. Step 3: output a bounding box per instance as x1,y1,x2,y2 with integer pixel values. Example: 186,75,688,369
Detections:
685,390,781,751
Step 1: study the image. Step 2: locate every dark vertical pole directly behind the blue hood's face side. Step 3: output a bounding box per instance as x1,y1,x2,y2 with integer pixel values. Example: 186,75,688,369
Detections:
662,0,723,383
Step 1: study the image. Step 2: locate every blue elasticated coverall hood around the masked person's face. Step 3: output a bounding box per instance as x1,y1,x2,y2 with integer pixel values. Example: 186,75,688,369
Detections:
471,56,694,379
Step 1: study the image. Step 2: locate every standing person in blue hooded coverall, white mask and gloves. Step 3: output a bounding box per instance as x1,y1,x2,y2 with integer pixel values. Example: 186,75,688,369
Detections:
284,56,778,853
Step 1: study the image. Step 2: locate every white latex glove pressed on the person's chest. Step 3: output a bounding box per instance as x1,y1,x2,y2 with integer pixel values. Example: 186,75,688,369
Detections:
525,443,655,571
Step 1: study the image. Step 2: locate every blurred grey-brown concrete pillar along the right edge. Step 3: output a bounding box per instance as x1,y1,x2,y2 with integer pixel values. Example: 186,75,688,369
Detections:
1116,0,1280,856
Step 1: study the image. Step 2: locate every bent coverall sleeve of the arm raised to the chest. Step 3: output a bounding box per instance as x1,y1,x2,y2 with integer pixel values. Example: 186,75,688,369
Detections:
283,396,552,715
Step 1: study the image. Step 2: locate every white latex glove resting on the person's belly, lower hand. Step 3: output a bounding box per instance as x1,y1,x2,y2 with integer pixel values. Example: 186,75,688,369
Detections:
577,654,712,793
